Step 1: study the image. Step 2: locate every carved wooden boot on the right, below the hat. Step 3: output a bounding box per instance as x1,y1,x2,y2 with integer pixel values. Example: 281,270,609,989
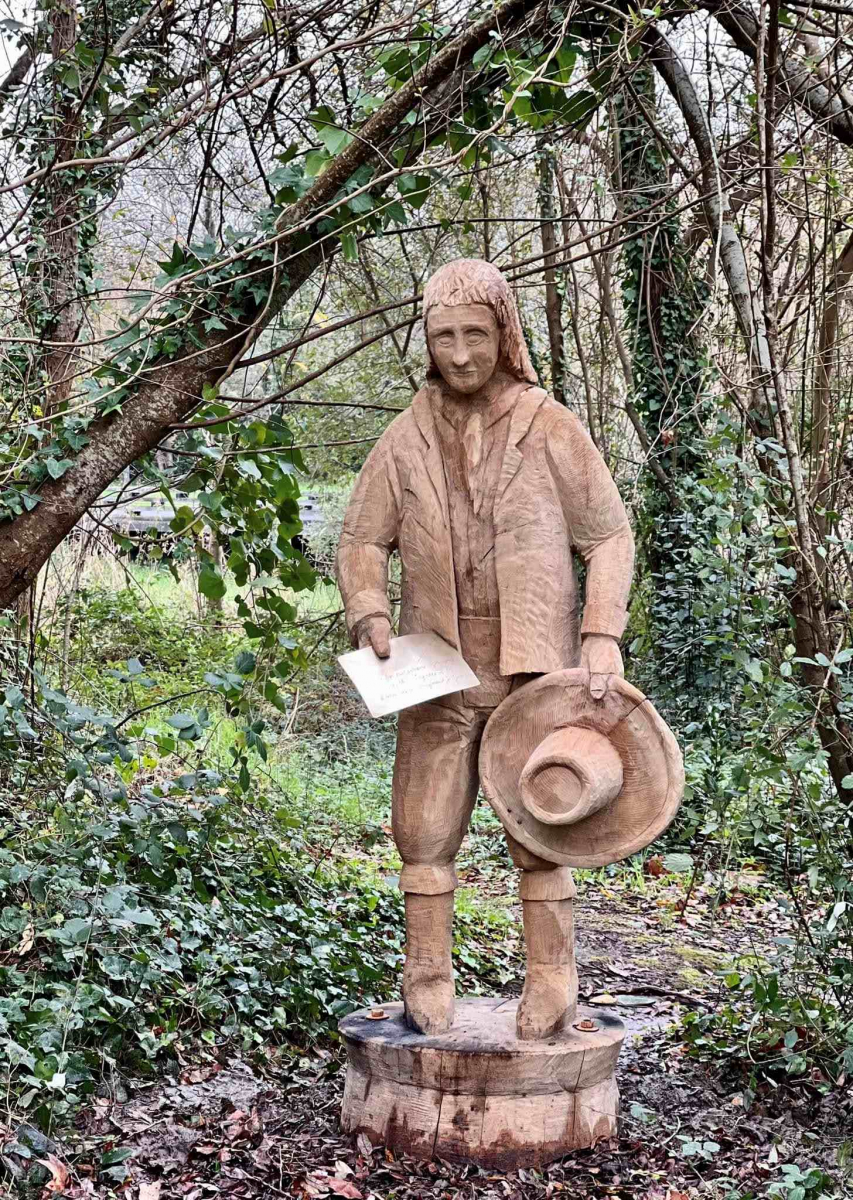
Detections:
516,900,577,1042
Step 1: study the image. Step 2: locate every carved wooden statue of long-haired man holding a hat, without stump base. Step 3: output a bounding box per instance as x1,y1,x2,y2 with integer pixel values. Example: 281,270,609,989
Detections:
337,259,680,1163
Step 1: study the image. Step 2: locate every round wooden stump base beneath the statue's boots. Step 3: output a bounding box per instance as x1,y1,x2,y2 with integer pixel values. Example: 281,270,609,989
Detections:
340,998,625,1171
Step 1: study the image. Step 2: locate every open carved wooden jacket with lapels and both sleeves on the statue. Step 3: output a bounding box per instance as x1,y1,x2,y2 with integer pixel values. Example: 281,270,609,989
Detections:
337,385,633,676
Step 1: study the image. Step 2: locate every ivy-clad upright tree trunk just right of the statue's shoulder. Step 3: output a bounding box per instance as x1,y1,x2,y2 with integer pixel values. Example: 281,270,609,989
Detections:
617,67,739,730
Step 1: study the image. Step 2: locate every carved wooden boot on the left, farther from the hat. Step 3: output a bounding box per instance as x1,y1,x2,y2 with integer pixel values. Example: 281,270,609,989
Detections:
403,892,455,1033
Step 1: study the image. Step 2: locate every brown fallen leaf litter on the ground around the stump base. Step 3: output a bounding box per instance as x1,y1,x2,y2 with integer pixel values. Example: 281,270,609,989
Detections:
0,875,853,1200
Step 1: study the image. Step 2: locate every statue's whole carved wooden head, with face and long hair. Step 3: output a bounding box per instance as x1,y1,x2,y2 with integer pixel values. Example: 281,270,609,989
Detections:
424,258,536,394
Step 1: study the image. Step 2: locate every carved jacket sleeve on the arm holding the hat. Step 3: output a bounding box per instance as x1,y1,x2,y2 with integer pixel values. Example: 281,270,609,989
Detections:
547,409,633,638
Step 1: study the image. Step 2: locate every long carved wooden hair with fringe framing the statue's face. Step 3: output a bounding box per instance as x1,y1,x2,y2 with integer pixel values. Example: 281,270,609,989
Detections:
424,258,539,383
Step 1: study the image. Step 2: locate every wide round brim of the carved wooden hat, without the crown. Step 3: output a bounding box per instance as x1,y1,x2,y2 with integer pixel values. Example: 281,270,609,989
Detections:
480,667,684,866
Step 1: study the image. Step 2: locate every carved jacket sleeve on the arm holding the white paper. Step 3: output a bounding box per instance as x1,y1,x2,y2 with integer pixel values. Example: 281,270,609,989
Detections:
337,422,402,646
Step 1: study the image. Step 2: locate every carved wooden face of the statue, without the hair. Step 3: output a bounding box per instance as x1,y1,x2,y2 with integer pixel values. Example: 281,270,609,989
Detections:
427,304,500,396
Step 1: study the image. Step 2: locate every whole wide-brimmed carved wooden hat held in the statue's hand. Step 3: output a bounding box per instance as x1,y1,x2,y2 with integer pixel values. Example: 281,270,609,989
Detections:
480,667,684,866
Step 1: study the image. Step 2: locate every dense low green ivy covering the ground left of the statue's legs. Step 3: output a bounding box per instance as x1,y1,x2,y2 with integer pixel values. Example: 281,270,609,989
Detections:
0,769,401,1123
